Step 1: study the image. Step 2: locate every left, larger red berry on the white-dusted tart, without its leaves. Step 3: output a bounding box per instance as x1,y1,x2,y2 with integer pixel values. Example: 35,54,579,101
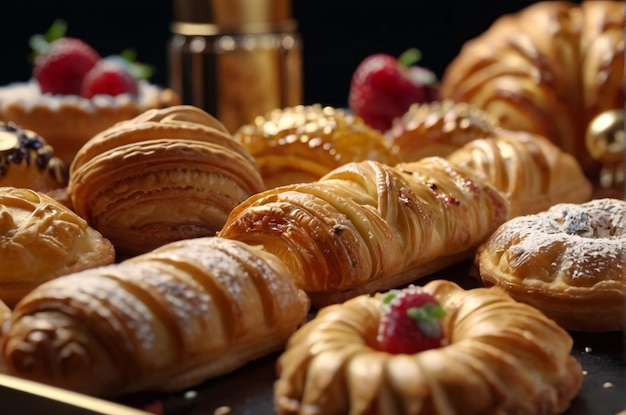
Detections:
33,37,101,95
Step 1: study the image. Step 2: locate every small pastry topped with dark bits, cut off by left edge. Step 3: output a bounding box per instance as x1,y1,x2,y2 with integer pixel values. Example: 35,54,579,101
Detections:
0,122,68,192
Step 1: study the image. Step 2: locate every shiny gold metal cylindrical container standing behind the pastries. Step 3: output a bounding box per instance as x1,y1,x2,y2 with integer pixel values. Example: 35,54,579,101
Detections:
168,0,302,132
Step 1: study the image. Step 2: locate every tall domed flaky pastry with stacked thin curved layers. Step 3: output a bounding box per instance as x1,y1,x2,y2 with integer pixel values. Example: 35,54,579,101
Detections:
68,106,265,256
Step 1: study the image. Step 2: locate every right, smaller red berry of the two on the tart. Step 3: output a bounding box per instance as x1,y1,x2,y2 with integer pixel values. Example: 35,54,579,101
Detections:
80,59,137,98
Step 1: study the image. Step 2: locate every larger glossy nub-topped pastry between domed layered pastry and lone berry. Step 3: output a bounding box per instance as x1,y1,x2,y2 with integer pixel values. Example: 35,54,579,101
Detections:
234,104,398,188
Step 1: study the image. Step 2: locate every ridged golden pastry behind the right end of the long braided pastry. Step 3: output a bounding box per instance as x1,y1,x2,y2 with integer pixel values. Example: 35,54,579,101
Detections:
448,129,593,217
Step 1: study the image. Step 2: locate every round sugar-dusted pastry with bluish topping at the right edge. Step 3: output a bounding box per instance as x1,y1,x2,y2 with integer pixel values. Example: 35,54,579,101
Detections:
476,198,626,332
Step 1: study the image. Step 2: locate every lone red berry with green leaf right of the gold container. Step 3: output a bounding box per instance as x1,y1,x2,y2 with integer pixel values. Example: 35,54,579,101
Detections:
348,49,439,131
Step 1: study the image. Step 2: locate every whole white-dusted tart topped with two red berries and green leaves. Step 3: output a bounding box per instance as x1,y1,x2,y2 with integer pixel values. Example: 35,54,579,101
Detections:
0,21,179,163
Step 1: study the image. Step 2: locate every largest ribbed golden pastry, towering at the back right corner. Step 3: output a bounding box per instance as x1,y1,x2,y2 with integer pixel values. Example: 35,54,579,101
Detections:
441,1,624,176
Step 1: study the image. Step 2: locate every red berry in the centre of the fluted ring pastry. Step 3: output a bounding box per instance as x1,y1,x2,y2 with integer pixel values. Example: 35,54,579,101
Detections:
378,285,445,354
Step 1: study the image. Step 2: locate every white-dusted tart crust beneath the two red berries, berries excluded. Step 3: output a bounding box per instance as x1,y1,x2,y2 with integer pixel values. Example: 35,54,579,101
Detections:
0,80,179,164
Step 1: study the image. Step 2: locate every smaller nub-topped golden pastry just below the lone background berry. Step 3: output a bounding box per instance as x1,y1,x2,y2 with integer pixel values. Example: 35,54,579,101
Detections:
387,100,498,162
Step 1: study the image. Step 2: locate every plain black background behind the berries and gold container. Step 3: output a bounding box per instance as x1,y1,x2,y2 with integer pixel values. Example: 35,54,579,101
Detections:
0,0,580,106
